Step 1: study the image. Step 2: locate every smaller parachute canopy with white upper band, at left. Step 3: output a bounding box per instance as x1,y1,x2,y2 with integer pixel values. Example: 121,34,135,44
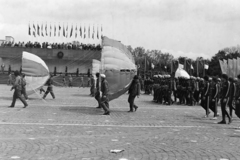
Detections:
22,51,50,95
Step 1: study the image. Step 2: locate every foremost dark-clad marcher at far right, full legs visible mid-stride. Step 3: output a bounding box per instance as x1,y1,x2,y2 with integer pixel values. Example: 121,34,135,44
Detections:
218,74,232,124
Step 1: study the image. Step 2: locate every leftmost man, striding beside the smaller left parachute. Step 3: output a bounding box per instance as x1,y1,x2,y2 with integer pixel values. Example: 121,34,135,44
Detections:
9,70,28,108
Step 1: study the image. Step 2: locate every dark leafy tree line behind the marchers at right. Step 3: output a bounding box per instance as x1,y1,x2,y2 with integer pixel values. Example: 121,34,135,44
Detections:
127,45,240,77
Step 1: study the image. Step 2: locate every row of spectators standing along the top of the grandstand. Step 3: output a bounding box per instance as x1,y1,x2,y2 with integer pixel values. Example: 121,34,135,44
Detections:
0,41,102,50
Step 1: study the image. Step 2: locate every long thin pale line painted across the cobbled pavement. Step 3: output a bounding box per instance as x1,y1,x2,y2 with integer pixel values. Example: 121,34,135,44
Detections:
0,122,209,128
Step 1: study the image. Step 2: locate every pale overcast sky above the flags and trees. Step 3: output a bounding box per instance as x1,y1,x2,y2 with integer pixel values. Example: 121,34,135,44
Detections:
0,0,240,58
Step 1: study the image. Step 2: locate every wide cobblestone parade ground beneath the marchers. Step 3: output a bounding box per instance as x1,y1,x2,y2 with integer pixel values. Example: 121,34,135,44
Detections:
0,85,240,160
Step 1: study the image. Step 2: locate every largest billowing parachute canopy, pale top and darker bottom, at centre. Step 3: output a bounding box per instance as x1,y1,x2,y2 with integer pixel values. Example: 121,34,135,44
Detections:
100,37,137,100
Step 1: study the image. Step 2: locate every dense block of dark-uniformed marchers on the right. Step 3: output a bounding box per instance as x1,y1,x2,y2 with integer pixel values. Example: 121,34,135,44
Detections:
152,74,240,124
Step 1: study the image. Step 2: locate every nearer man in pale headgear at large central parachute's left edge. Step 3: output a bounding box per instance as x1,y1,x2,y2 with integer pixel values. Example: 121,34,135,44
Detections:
101,74,110,115
